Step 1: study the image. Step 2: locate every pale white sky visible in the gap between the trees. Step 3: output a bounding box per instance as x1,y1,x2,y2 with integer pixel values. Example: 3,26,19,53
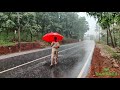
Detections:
78,12,97,35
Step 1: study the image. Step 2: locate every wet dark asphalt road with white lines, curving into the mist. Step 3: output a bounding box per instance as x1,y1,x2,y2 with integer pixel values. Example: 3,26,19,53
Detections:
0,40,94,78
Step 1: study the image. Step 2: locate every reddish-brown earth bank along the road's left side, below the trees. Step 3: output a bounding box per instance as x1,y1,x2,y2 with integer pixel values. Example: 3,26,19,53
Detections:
0,39,78,55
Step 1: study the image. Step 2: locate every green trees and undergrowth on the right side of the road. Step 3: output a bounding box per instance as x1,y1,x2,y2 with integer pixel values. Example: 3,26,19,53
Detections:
87,12,120,47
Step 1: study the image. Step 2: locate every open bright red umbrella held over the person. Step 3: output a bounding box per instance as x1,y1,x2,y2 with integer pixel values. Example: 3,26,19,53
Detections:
42,32,63,42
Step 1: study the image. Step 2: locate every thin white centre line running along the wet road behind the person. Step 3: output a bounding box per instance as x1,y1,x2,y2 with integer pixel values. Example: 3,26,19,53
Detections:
0,45,79,74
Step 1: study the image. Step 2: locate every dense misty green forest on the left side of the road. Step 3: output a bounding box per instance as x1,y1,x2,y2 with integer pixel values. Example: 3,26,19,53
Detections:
0,12,89,44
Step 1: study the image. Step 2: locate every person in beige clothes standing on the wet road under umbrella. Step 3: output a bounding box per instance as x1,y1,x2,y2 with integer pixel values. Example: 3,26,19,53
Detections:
50,37,60,66
